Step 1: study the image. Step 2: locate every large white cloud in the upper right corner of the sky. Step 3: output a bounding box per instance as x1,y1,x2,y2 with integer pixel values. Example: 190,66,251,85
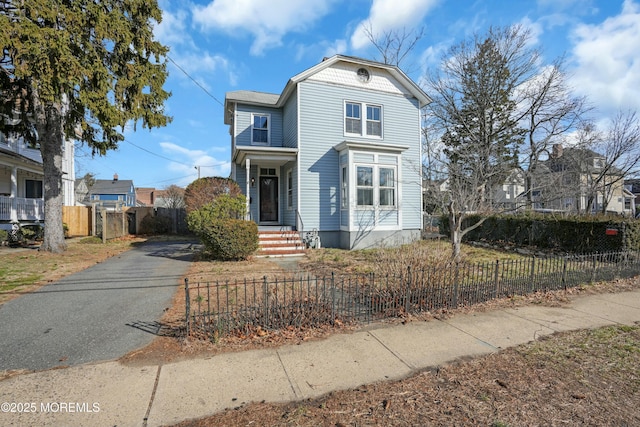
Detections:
571,0,640,112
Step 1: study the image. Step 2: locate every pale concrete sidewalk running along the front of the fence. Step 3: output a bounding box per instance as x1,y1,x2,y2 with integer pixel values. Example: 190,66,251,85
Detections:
0,291,640,426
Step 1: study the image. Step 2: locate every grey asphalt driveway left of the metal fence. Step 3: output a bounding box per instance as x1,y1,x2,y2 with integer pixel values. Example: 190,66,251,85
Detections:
0,242,194,370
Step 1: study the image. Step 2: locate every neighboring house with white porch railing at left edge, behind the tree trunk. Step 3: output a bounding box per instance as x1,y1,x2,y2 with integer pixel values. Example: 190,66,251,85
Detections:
0,133,75,230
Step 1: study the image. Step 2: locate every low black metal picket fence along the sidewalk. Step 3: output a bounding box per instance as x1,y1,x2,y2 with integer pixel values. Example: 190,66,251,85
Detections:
185,252,640,339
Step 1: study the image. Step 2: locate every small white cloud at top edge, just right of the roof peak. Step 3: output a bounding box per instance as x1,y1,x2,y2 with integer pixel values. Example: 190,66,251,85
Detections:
351,0,439,49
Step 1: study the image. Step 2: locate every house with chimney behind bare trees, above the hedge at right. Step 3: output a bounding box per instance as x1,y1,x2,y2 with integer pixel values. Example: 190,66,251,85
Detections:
536,144,635,215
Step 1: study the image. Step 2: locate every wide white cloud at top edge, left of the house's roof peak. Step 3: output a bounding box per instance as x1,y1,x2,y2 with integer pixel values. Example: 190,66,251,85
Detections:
192,0,335,56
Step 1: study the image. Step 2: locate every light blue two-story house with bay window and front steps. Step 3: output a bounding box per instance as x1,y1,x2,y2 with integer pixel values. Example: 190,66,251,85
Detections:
224,55,430,249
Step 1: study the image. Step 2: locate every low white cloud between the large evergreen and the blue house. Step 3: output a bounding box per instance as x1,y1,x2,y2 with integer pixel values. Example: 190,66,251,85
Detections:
160,142,231,185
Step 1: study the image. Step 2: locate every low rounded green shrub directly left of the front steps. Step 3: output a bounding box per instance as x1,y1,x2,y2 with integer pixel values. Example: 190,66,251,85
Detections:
198,218,258,261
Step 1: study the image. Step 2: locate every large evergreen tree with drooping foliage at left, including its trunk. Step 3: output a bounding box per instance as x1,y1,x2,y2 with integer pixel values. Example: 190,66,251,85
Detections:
0,0,170,252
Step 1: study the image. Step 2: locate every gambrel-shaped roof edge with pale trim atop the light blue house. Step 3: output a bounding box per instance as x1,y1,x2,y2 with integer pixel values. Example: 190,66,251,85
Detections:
224,55,431,124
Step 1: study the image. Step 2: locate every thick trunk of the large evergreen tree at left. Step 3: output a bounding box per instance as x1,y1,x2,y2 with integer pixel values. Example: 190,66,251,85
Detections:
38,103,67,253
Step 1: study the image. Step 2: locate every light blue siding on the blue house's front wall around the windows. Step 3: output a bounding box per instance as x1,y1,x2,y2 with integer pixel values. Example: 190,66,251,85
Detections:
298,81,422,231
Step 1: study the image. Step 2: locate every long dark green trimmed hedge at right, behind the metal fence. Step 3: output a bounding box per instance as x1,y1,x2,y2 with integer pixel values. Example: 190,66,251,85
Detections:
440,214,640,253
